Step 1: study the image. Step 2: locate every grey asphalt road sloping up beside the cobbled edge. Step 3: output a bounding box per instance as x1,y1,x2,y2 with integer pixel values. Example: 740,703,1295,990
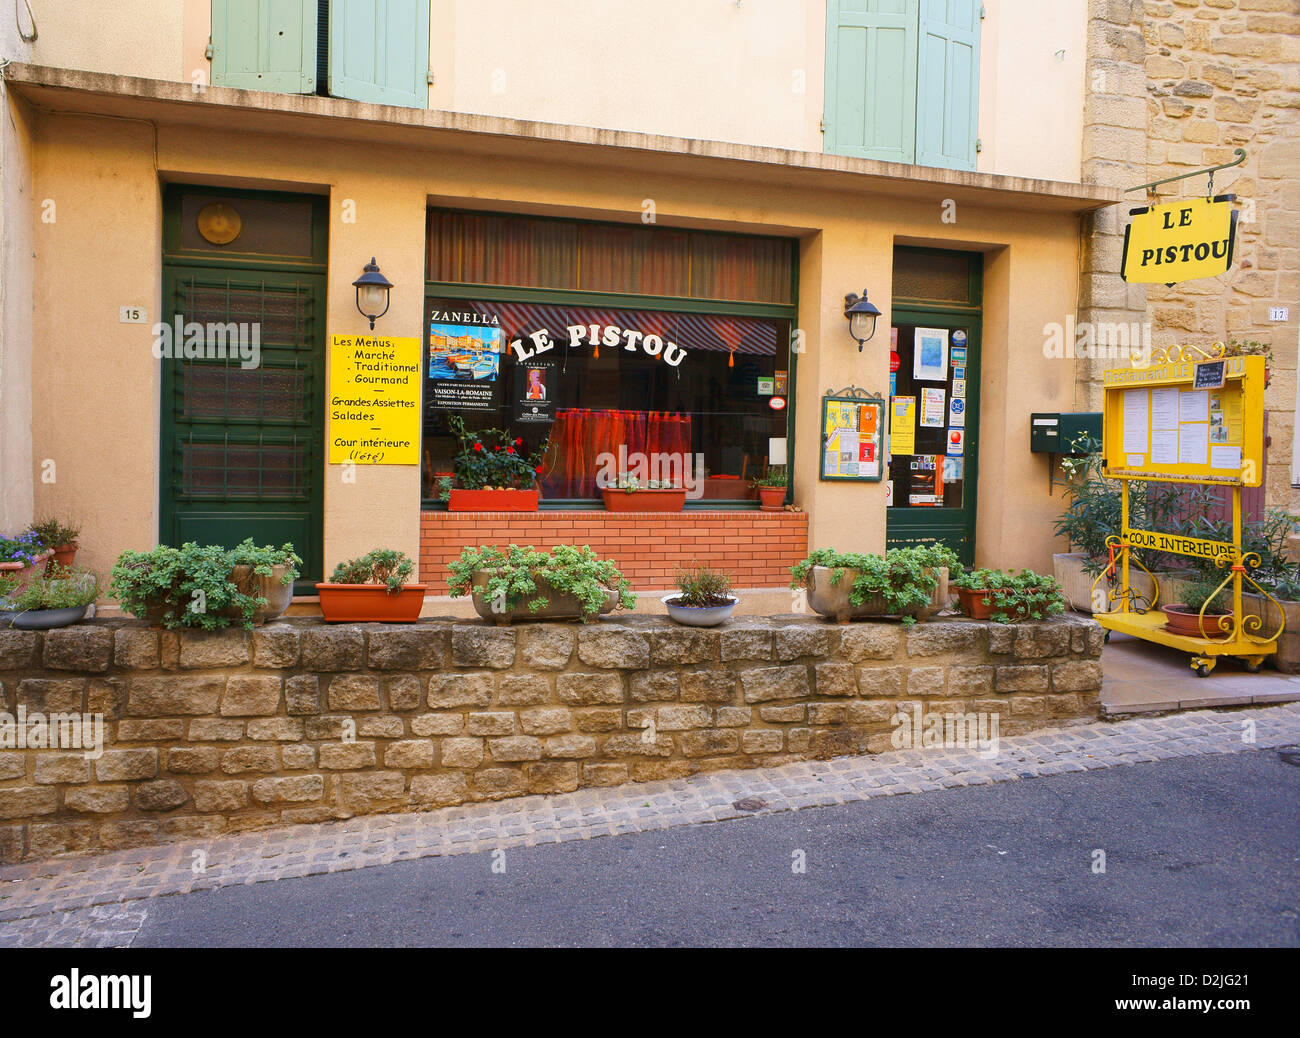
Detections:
135,751,1300,947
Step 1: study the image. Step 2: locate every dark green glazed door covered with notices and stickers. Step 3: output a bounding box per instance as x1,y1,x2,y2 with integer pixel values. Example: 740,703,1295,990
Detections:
885,304,980,566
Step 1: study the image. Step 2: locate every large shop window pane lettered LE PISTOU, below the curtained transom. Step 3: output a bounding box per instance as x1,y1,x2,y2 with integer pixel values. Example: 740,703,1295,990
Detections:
423,297,790,506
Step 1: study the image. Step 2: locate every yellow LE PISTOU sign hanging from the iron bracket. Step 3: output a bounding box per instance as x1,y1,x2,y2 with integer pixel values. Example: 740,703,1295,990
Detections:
1122,195,1236,285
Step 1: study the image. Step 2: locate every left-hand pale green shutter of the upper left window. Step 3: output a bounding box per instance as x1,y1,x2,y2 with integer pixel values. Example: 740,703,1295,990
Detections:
212,0,316,94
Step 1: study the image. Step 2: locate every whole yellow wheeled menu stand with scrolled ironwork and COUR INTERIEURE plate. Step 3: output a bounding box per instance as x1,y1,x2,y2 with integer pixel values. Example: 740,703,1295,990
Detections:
1092,342,1286,678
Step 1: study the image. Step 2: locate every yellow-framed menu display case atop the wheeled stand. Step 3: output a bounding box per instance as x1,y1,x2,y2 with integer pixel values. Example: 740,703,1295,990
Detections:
1102,346,1265,486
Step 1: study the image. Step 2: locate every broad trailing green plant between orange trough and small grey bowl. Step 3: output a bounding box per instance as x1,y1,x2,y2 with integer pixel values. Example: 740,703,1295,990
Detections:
447,544,637,623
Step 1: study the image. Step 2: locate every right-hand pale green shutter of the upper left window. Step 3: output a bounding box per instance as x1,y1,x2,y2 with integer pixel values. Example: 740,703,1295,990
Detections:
329,0,429,108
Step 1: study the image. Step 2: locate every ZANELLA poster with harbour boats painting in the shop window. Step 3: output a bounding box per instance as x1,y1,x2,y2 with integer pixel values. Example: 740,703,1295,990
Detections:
428,306,503,411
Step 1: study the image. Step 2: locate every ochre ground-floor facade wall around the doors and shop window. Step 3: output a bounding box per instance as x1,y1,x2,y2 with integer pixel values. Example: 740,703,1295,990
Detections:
25,113,1078,590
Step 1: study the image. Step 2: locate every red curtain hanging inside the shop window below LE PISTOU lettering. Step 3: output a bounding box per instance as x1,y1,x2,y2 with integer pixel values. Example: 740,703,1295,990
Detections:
542,407,690,498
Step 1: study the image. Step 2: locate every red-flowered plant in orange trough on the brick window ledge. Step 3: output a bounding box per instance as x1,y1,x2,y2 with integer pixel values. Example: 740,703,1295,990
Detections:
447,415,550,511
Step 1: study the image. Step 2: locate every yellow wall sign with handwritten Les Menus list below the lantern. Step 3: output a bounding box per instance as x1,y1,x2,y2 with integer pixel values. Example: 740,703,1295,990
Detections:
328,336,421,464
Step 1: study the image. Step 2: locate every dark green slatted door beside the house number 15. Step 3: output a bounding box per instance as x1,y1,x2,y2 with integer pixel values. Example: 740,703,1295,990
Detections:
160,264,325,581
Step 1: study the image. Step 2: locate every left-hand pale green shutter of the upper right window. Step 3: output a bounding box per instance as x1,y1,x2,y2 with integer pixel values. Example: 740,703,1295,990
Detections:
826,0,918,163
